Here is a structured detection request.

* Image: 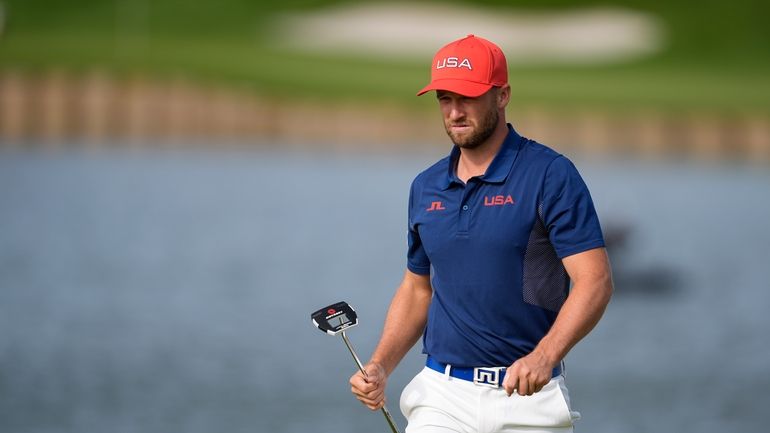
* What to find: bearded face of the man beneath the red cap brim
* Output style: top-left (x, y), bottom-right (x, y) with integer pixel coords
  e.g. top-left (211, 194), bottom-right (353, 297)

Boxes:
top-left (436, 87), bottom-right (500, 149)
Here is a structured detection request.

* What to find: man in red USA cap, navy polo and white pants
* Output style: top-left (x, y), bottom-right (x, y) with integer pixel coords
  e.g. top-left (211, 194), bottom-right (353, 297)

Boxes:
top-left (350, 35), bottom-right (612, 433)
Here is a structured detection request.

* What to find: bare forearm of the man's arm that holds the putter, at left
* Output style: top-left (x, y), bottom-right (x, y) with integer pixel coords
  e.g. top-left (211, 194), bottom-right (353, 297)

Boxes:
top-left (371, 272), bottom-right (432, 374)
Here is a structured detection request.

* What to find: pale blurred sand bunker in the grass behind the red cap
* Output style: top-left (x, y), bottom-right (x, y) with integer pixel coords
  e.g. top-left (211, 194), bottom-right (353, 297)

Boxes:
top-left (275, 3), bottom-right (663, 63)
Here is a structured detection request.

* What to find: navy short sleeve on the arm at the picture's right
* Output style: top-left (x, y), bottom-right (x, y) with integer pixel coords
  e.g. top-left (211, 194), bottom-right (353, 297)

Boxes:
top-left (539, 156), bottom-right (604, 259)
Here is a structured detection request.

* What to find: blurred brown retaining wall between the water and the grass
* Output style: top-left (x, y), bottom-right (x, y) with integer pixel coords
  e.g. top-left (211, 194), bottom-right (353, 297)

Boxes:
top-left (0, 72), bottom-right (770, 163)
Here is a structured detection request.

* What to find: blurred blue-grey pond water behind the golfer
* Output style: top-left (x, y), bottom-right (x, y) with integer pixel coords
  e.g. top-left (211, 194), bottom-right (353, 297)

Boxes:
top-left (0, 150), bottom-right (770, 433)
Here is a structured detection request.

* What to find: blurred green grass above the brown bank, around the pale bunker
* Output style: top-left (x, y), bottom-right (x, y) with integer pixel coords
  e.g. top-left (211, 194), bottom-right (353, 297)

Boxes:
top-left (0, 0), bottom-right (770, 114)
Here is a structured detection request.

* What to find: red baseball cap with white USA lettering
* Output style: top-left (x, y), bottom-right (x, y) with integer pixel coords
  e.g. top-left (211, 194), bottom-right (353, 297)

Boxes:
top-left (417, 35), bottom-right (508, 98)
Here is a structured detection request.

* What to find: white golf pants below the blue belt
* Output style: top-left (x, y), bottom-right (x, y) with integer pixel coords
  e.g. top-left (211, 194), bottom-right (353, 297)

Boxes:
top-left (400, 367), bottom-right (580, 433)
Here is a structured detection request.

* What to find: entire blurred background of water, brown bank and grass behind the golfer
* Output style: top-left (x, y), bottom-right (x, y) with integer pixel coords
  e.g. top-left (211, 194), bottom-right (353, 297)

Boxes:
top-left (0, 0), bottom-right (770, 433)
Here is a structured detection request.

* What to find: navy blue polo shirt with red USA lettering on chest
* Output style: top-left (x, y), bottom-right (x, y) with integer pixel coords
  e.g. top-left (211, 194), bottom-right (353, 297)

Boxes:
top-left (407, 125), bottom-right (604, 367)
